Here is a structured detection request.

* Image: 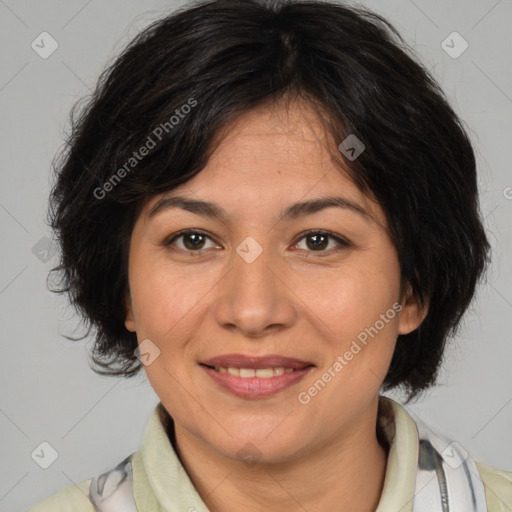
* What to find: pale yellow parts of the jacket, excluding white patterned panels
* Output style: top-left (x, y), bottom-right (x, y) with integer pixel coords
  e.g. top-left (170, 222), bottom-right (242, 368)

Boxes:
top-left (27, 398), bottom-right (512, 512)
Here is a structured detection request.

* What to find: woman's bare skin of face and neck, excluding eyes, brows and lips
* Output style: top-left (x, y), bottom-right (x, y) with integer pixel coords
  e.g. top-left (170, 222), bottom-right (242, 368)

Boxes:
top-left (125, 97), bottom-right (427, 512)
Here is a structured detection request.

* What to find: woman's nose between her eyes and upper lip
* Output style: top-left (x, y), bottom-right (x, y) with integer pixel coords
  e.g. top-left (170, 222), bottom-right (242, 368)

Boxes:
top-left (214, 241), bottom-right (297, 338)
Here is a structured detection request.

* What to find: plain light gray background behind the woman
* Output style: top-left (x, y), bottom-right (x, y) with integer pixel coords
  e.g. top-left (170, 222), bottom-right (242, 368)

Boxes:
top-left (0, 0), bottom-right (512, 511)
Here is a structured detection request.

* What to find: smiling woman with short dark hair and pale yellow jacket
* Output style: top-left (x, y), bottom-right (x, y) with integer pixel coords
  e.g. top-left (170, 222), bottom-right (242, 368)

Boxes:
top-left (31, 0), bottom-right (512, 512)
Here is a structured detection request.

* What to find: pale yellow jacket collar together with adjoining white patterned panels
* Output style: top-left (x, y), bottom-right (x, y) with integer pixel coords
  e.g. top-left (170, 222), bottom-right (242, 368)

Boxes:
top-left (90, 397), bottom-right (487, 512)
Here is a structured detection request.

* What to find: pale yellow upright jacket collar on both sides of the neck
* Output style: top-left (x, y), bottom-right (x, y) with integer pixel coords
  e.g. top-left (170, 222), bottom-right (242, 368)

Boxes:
top-left (132, 397), bottom-right (419, 512)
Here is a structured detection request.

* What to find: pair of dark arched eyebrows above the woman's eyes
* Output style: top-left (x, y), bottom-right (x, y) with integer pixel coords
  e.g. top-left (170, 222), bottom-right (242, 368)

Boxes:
top-left (147, 196), bottom-right (376, 222)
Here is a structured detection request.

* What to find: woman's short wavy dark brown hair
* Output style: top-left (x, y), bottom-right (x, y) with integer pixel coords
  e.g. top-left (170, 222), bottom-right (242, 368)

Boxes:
top-left (48, 0), bottom-right (490, 398)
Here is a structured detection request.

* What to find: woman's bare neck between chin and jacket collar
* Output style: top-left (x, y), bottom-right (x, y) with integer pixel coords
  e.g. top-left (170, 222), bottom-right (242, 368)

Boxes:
top-left (161, 397), bottom-right (388, 512)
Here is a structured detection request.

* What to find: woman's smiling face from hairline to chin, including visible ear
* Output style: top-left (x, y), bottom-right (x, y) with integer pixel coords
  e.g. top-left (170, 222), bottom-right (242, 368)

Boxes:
top-left (126, 99), bottom-right (424, 462)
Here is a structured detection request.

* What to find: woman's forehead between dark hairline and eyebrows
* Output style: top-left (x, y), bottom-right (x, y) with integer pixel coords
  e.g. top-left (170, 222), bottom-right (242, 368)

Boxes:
top-left (145, 97), bottom-right (386, 225)
